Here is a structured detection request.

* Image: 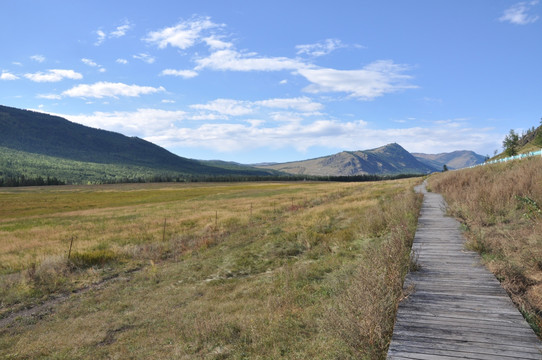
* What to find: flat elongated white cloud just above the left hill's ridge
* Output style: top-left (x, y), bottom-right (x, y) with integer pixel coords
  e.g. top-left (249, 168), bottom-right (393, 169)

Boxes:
top-left (62, 82), bottom-right (165, 99)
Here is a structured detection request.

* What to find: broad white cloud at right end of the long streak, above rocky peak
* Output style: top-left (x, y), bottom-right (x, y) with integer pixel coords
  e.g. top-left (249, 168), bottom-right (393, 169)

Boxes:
top-left (298, 61), bottom-right (417, 100)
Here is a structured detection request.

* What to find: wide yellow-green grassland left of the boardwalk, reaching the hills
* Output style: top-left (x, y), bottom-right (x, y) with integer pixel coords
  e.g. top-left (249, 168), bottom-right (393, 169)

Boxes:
top-left (0, 179), bottom-right (421, 359)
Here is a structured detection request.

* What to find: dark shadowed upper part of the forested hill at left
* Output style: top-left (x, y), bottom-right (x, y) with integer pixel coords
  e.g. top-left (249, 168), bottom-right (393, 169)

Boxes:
top-left (0, 106), bottom-right (268, 179)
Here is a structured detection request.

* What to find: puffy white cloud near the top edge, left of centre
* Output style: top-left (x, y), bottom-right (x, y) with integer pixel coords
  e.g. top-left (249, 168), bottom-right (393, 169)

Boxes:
top-left (143, 17), bottom-right (222, 50)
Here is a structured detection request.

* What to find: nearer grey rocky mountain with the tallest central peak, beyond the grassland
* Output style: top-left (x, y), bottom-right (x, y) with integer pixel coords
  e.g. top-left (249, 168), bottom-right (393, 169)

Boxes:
top-left (258, 144), bottom-right (437, 176)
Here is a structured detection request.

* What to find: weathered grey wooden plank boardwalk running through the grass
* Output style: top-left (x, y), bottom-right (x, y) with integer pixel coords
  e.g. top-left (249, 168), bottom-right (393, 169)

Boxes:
top-left (387, 186), bottom-right (542, 359)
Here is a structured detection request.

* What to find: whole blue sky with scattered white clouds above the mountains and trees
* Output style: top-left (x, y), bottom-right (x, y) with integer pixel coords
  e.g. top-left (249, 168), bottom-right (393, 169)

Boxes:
top-left (0, 0), bottom-right (542, 163)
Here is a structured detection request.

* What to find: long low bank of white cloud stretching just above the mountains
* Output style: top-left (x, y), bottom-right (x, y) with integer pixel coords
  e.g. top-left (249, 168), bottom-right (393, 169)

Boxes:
top-left (44, 105), bottom-right (500, 162)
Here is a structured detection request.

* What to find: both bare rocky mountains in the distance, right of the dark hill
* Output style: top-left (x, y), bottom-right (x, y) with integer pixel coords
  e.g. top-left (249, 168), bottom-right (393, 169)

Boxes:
top-left (254, 143), bottom-right (484, 176)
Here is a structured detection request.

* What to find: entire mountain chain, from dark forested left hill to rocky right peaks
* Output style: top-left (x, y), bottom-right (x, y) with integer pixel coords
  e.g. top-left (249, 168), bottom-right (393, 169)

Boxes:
top-left (0, 106), bottom-right (484, 183)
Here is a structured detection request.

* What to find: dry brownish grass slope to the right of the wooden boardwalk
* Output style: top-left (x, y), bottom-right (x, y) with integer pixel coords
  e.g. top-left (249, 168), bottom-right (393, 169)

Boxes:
top-left (429, 158), bottom-right (542, 335)
